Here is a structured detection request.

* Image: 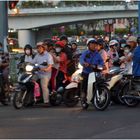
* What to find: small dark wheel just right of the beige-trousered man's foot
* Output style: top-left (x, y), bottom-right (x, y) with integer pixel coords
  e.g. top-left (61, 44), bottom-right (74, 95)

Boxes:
top-left (50, 93), bottom-right (62, 106)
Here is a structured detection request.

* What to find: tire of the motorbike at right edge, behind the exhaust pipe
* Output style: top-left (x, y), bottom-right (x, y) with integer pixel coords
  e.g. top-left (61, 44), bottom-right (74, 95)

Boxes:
top-left (122, 83), bottom-right (139, 107)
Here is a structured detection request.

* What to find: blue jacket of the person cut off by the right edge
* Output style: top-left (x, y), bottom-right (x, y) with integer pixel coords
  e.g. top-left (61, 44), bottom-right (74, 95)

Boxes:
top-left (132, 46), bottom-right (140, 76)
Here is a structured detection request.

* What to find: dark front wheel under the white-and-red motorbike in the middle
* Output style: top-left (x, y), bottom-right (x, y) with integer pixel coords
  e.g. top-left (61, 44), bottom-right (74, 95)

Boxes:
top-left (63, 88), bottom-right (79, 107)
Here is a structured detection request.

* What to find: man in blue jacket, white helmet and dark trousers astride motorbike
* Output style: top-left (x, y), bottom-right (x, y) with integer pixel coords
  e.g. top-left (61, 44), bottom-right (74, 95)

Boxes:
top-left (80, 38), bottom-right (104, 104)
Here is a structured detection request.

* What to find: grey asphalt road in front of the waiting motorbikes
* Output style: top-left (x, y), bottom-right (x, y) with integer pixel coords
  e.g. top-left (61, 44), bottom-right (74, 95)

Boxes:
top-left (0, 105), bottom-right (140, 139)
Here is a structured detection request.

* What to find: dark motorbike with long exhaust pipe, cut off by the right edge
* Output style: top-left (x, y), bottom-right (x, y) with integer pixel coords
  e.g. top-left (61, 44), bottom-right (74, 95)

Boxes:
top-left (122, 74), bottom-right (140, 107)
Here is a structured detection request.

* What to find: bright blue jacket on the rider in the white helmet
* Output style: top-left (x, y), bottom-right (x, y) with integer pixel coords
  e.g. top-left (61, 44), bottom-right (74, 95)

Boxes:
top-left (80, 50), bottom-right (104, 74)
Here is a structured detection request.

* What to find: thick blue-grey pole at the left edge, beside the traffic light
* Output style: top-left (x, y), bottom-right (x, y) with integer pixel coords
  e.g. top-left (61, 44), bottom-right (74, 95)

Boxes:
top-left (0, 1), bottom-right (8, 52)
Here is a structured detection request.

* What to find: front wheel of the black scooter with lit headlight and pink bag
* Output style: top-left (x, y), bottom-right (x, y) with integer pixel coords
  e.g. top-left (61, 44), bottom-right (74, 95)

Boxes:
top-left (13, 90), bottom-right (27, 109)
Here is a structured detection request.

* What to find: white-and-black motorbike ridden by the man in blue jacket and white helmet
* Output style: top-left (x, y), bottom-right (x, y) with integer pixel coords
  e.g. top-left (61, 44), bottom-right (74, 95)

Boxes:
top-left (84, 66), bottom-right (110, 111)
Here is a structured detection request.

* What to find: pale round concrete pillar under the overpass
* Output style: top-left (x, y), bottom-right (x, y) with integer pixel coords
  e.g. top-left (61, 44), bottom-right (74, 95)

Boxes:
top-left (18, 30), bottom-right (36, 48)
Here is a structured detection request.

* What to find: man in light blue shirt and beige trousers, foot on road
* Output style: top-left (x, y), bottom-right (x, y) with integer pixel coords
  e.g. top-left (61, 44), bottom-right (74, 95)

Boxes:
top-left (33, 42), bottom-right (53, 107)
